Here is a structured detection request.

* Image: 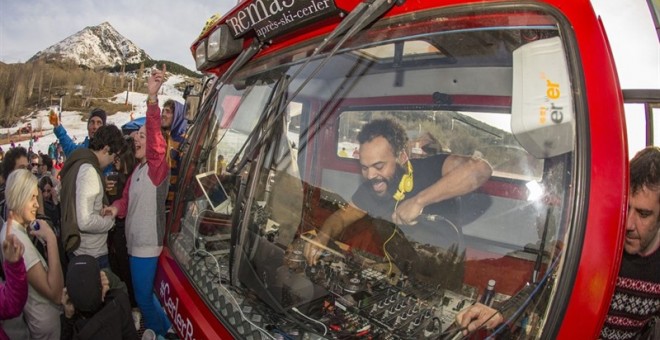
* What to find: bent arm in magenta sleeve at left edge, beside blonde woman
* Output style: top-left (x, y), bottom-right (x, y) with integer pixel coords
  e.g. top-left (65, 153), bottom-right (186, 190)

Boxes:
top-left (0, 234), bottom-right (27, 339)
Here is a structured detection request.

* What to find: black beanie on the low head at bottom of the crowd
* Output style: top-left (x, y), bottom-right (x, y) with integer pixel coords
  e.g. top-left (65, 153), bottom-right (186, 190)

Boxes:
top-left (66, 255), bottom-right (103, 313)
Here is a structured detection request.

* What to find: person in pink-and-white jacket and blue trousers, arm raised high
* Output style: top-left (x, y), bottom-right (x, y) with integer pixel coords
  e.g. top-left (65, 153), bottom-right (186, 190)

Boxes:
top-left (102, 65), bottom-right (171, 337)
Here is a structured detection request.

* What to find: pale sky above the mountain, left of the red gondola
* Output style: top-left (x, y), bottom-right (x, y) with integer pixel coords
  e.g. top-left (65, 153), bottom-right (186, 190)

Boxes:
top-left (0, 0), bottom-right (236, 70)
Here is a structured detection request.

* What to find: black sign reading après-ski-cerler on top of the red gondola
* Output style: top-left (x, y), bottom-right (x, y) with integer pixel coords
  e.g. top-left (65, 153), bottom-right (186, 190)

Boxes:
top-left (226, 0), bottom-right (337, 40)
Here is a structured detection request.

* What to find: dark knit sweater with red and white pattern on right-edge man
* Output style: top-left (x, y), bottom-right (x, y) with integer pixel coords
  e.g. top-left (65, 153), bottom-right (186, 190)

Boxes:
top-left (600, 250), bottom-right (660, 340)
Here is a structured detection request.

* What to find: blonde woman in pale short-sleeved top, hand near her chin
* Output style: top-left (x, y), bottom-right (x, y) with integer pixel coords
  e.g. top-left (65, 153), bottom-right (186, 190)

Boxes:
top-left (0, 169), bottom-right (64, 339)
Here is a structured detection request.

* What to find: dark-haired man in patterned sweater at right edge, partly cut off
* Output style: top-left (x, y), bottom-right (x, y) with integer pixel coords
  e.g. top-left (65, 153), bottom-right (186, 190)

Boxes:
top-left (600, 146), bottom-right (660, 340)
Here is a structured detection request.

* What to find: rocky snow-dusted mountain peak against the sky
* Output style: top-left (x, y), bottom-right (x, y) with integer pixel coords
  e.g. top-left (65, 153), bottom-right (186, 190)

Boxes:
top-left (30, 21), bottom-right (151, 69)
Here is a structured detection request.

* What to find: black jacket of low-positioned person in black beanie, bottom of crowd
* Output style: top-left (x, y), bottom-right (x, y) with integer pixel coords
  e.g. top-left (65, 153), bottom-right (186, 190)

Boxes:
top-left (60, 289), bottom-right (138, 340)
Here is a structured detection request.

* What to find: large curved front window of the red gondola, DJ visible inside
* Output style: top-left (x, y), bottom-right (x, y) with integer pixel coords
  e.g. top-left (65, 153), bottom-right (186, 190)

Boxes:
top-left (170, 5), bottom-right (579, 339)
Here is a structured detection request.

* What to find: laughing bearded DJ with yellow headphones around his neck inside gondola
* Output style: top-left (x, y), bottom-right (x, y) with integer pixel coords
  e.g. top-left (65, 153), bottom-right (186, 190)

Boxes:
top-left (304, 119), bottom-right (492, 264)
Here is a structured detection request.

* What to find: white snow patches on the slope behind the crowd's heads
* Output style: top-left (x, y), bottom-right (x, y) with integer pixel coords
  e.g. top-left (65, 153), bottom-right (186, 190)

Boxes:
top-left (0, 75), bottom-right (183, 153)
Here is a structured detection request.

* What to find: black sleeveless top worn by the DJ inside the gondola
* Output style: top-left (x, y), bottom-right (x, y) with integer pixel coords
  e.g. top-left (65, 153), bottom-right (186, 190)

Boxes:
top-left (352, 154), bottom-right (462, 249)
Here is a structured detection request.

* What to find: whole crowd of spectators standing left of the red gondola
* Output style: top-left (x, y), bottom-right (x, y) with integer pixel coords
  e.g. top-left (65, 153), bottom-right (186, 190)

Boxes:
top-left (0, 68), bottom-right (187, 340)
